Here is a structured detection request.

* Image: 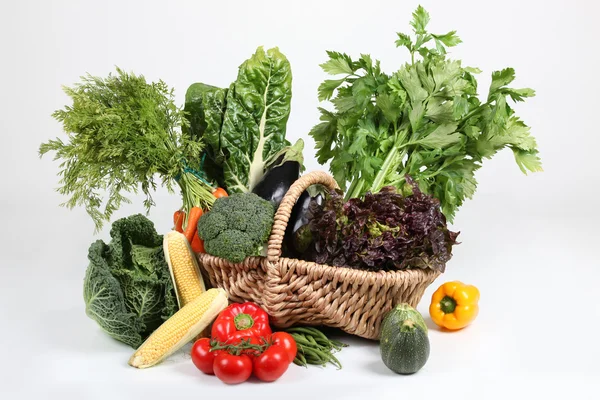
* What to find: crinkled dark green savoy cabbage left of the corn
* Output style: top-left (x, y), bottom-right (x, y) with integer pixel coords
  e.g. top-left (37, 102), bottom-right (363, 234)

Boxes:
top-left (83, 214), bottom-right (177, 348)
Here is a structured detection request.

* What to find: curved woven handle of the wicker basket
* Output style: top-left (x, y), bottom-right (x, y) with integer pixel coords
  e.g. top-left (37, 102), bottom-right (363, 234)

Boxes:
top-left (267, 171), bottom-right (338, 265)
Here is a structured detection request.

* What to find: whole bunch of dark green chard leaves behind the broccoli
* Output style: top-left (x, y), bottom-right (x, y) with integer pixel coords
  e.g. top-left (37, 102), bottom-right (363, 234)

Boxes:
top-left (186, 47), bottom-right (302, 193)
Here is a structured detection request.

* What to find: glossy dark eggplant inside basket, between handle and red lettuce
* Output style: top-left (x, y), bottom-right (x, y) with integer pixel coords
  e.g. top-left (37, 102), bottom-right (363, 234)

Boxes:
top-left (283, 190), bottom-right (323, 258)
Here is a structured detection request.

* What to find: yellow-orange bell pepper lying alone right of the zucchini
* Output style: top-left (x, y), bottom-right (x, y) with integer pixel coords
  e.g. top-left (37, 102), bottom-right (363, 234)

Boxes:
top-left (429, 281), bottom-right (479, 330)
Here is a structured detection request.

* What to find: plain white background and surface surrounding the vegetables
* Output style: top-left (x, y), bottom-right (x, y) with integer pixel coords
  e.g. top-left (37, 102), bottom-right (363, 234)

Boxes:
top-left (0, 0), bottom-right (600, 399)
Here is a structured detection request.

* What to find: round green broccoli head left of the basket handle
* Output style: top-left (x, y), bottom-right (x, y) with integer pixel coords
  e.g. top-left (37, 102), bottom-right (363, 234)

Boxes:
top-left (198, 193), bottom-right (275, 262)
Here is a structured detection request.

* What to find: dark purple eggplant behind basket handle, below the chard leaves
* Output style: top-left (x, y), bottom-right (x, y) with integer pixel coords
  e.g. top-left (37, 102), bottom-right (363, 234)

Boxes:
top-left (252, 161), bottom-right (300, 209)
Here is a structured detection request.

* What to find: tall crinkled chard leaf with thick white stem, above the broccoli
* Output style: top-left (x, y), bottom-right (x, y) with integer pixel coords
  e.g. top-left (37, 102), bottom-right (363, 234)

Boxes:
top-left (221, 47), bottom-right (292, 193)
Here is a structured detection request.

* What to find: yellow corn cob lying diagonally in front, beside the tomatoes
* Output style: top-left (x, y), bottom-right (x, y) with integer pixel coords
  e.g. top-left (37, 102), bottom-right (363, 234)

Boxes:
top-left (129, 289), bottom-right (227, 368)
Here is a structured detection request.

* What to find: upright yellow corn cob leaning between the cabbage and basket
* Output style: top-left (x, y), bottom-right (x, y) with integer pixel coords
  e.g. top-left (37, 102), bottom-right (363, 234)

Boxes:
top-left (163, 231), bottom-right (206, 307)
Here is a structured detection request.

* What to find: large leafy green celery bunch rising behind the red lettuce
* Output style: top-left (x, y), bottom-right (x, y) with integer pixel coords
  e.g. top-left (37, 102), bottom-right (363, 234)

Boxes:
top-left (310, 6), bottom-right (542, 220)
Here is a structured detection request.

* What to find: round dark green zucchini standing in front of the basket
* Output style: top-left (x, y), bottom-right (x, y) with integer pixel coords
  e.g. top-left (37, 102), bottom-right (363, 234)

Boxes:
top-left (379, 304), bottom-right (430, 374)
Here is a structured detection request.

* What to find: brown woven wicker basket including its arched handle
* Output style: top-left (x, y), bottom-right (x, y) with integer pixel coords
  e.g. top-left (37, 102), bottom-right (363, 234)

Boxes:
top-left (199, 171), bottom-right (439, 339)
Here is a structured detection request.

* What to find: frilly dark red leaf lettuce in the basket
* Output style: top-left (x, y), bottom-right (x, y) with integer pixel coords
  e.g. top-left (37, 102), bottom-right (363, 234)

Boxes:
top-left (307, 177), bottom-right (458, 272)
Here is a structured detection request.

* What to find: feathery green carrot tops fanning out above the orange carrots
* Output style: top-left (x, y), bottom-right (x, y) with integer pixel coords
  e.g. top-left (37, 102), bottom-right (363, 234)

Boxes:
top-left (39, 68), bottom-right (214, 230)
